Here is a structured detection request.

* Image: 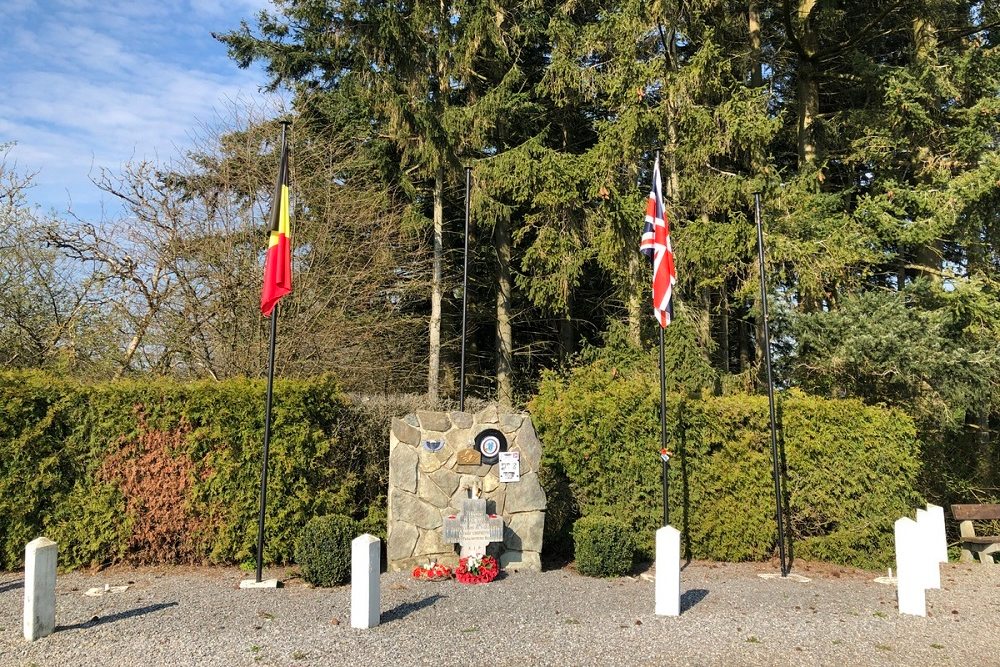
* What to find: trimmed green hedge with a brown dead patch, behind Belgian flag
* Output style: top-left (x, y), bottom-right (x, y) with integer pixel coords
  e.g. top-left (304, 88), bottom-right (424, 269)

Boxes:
top-left (0, 373), bottom-right (388, 569)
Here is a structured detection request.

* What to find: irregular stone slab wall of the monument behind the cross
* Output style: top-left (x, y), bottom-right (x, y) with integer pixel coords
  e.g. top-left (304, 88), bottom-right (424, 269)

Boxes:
top-left (387, 406), bottom-right (545, 570)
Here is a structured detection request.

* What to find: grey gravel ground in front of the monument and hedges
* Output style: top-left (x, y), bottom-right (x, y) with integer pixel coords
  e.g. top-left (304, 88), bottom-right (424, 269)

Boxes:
top-left (0, 562), bottom-right (1000, 667)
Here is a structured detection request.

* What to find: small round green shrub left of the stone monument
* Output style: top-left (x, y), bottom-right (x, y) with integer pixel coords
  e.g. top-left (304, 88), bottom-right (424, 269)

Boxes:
top-left (295, 514), bottom-right (361, 586)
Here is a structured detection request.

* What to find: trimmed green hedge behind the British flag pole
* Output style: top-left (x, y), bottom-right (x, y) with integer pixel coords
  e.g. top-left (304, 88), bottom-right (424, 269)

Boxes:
top-left (531, 359), bottom-right (920, 568)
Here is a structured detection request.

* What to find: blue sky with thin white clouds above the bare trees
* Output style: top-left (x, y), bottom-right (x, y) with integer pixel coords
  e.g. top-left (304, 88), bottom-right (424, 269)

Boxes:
top-left (0, 0), bottom-right (278, 218)
